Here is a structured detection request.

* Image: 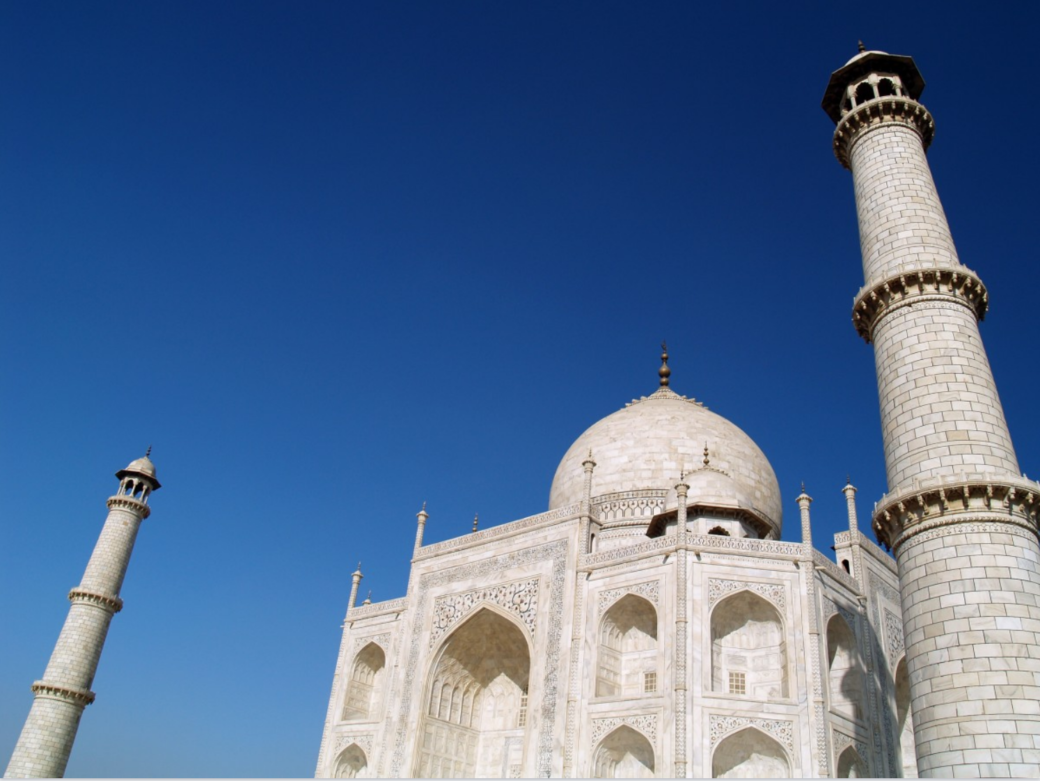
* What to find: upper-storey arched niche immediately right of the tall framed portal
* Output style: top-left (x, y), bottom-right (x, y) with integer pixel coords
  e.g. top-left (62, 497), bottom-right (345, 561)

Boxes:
top-left (596, 594), bottom-right (657, 697)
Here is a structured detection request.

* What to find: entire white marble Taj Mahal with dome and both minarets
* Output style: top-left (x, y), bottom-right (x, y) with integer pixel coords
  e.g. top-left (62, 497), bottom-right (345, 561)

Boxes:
top-left (6, 47), bottom-right (1040, 778)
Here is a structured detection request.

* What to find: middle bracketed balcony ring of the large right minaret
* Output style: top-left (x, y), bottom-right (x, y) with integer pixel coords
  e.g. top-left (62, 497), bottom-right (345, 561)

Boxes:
top-left (852, 266), bottom-right (989, 344)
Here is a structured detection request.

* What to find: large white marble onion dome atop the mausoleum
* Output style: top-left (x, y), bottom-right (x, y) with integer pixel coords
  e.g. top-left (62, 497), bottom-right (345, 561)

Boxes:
top-left (549, 388), bottom-right (783, 538)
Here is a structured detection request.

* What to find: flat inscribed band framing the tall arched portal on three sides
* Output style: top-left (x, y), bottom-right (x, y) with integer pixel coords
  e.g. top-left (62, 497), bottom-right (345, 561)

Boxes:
top-left (389, 540), bottom-right (568, 778)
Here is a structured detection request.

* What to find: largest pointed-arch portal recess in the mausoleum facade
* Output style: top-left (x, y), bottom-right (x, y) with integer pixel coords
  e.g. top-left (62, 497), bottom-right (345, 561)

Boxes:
top-left (415, 607), bottom-right (530, 778)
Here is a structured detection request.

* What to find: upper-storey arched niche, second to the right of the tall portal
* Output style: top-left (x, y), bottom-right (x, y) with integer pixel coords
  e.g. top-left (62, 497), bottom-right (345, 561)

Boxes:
top-left (711, 591), bottom-right (788, 700)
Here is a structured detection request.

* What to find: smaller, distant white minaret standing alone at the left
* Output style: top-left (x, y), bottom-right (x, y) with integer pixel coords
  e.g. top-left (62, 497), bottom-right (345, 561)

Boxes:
top-left (4, 448), bottom-right (159, 778)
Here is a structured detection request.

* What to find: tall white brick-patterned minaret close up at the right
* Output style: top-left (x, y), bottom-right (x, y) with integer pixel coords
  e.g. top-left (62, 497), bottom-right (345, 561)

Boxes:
top-left (823, 45), bottom-right (1040, 777)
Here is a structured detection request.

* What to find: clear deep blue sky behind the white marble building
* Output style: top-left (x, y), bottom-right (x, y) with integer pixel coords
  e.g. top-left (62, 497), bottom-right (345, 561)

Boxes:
top-left (0, 2), bottom-right (1040, 776)
